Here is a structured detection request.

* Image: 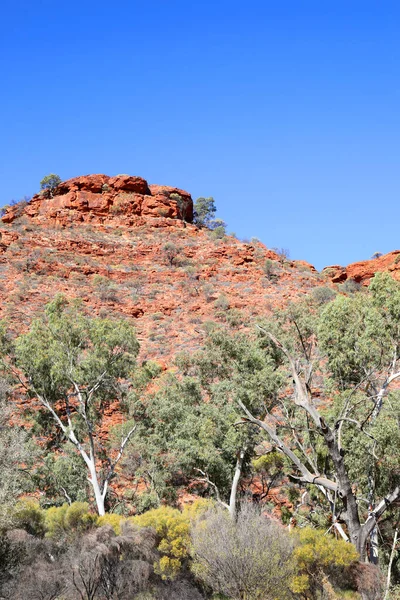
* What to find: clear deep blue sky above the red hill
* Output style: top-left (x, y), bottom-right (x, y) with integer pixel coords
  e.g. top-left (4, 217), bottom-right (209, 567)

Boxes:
top-left (0, 0), bottom-right (400, 268)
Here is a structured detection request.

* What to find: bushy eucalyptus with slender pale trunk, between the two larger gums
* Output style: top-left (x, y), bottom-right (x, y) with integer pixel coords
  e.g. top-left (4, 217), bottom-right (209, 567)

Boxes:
top-left (128, 326), bottom-right (280, 517)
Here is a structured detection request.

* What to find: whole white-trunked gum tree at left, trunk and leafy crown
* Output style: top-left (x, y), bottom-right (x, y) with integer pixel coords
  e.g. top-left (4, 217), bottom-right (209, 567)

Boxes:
top-left (10, 296), bottom-right (139, 515)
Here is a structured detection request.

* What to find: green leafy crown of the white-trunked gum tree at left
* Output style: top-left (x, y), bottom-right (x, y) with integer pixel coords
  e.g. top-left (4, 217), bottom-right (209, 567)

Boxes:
top-left (16, 296), bottom-right (139, 403)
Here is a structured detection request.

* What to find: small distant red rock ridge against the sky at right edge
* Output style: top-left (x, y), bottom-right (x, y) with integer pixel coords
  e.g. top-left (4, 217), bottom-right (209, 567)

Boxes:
top-left (322, 250), bottom-right (400, 285)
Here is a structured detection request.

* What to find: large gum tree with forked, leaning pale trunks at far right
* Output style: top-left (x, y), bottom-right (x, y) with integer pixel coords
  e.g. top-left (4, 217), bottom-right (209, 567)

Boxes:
top-left (239, 274), bottom-right (400, 562)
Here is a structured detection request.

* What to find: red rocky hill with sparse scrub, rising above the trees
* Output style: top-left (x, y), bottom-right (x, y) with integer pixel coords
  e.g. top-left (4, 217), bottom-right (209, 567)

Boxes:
top-left (0, 175), bottom-right (400, 365)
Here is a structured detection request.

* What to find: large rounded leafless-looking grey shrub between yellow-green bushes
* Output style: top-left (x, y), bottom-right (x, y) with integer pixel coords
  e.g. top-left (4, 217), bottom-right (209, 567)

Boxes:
top-left (192, 505), bottom-right (294, 600)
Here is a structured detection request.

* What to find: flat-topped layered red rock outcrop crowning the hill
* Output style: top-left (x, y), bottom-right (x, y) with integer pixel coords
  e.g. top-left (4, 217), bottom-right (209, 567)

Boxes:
top-left (2, 175), bottom-right (193, 226)
